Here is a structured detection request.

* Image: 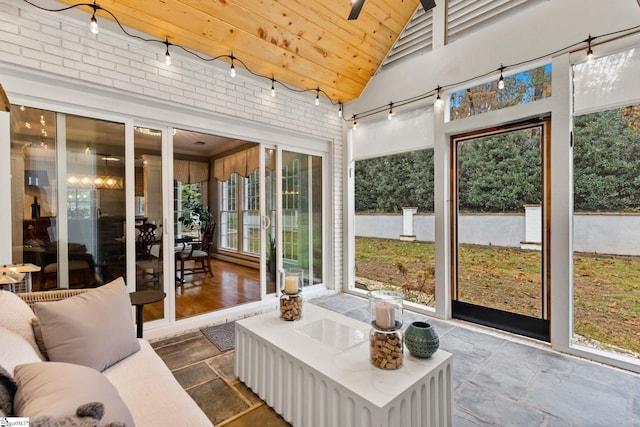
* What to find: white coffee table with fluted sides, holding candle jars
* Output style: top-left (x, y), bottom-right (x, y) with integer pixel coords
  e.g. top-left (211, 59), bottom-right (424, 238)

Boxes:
top-left (235, 303), bottom-right (452, 427)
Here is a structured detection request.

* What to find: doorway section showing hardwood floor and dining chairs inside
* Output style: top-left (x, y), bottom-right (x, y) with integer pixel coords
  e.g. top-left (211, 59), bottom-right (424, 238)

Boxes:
top-left (172, 129), bottom-right (263, 319)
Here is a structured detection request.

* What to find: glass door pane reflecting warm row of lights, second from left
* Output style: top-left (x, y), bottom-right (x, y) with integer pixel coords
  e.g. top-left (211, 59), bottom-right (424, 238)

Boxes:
top-left (65, 115), bottom-right (127, 287)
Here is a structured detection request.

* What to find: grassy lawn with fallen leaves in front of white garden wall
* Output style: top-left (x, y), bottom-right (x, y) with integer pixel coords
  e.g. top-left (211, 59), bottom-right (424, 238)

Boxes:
top-left (356, 237), bottom-right (640, 353)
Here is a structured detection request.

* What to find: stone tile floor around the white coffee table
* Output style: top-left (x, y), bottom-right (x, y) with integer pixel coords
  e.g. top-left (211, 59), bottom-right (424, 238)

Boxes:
top-left (153, 294), bottom-right (640, 427)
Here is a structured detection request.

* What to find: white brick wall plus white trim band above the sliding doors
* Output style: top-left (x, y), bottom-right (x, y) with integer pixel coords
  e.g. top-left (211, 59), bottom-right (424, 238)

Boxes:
top-left (0, 0), bottom-right (343, 300)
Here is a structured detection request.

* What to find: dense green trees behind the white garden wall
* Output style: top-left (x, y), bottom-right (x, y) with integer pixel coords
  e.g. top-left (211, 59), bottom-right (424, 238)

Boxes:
top-left (355, 102), bottom-right (640, 213)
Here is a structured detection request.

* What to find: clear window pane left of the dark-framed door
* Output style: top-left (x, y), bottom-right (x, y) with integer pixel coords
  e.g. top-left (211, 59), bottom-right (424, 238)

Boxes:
top-left (355, 150), bottom-right (435, 306)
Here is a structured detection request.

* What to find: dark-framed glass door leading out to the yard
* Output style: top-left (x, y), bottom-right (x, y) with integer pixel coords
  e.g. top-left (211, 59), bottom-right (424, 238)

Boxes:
top-left (451, 119), bottom-right (548, 339)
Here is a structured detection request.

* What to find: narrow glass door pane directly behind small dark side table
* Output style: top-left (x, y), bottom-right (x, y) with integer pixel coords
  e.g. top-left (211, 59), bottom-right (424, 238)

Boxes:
top-left (134, 126), bottom-right (165, 321)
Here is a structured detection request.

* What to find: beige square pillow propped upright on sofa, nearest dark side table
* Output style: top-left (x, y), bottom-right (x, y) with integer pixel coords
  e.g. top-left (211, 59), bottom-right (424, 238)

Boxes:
top-left (34, 278), bottom-right (140, 371)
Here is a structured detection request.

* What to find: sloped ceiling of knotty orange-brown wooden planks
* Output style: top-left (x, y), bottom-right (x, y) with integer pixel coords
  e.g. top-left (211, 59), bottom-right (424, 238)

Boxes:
top-left (60, 0), bottom-right (420, 102)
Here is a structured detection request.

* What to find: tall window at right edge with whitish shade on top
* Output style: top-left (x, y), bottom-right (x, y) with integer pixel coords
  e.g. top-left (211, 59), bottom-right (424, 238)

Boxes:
top-left (572, 48), bottom-right (640, 358)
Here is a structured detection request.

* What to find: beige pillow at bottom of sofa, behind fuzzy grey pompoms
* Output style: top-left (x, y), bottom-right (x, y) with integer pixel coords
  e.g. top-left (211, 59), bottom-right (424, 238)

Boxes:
top-left (13, 362), bottom-right (134, 426)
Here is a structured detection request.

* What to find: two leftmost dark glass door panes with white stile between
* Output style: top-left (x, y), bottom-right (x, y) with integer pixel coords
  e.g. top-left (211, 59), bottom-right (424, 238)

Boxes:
top-left (11, 106), bottom-right (126, 290)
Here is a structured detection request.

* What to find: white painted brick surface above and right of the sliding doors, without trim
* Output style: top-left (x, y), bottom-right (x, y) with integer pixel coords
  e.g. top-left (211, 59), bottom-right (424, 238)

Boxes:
top-left (0, 0), bottom-right (343, 286)
